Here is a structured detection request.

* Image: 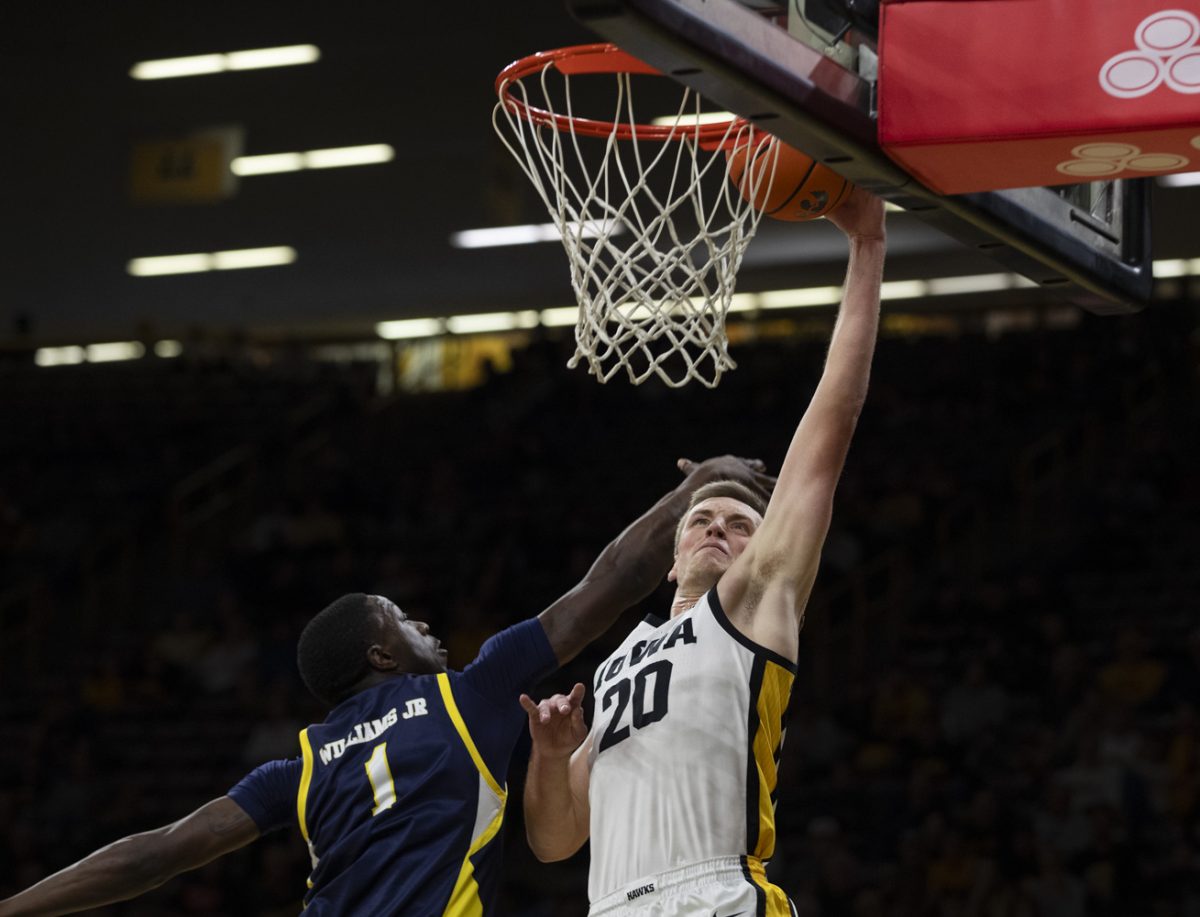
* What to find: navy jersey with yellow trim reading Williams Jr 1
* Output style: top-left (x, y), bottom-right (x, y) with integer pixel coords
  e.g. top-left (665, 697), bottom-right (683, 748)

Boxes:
top-left (229, 619), bottom-right (558, 917)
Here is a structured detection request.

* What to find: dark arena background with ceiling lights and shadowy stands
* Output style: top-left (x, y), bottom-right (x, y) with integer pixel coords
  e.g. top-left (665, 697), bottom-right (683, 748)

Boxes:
top-left (0, 0), bottom-right (1200, 917)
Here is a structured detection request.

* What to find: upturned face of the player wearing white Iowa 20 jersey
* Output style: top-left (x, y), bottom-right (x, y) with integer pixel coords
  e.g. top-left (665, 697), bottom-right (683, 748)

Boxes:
top-left (667, 497), bottom-right (762, 591)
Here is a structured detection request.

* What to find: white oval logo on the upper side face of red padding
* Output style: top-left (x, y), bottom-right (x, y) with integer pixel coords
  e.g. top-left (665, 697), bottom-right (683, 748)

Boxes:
top-left (1100, 10), bottom-right (1200, 98)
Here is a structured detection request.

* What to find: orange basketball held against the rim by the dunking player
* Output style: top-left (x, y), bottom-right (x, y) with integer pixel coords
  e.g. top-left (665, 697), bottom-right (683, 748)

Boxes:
top-left (726, 138), bottom-right (853, 222)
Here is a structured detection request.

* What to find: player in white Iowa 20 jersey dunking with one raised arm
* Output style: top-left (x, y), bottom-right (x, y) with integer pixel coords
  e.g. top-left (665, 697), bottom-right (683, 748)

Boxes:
top-left (522, 190), bottom-right (886, 917)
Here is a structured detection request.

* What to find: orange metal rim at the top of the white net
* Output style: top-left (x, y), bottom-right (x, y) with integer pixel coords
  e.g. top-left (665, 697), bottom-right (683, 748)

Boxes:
top-left (496, 43), bottom-right (740, 146)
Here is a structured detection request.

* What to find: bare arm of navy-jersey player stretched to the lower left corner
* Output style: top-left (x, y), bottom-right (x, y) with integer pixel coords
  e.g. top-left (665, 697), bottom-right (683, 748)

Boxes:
top-left (0, 796), bottom-right (258, 917)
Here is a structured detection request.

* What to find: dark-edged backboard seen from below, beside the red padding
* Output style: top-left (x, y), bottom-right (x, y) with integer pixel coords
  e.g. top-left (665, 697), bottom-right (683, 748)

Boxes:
top-left (566, 0), bottom-right (1153, 313)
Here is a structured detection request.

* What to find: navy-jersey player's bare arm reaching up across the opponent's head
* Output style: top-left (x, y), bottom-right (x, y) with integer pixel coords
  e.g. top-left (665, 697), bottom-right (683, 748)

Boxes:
top-left (538, 455), bottom-right (774, 665)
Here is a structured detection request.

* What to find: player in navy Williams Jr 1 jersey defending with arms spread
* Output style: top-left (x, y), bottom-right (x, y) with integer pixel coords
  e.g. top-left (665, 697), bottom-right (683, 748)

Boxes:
top-left (0, 456), bottom-right (772, 917)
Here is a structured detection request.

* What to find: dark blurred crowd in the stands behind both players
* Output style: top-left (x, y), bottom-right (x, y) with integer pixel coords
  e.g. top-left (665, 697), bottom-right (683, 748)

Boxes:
top-left (0, 306), bottom-right (1200, 917)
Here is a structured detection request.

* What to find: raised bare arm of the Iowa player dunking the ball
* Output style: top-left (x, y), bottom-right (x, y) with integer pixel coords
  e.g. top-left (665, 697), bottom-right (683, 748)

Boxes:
top-left (718, 190), bottom-right (886, 659)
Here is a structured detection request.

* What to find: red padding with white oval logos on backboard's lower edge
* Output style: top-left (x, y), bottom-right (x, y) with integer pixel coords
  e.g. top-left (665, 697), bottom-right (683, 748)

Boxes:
top-left (878, 0), bottom-right (1200, 193)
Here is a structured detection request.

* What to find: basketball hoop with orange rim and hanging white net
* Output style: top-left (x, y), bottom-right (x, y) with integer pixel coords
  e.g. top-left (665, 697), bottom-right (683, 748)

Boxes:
top-left (492, 44), bottom-right (775, 388)
